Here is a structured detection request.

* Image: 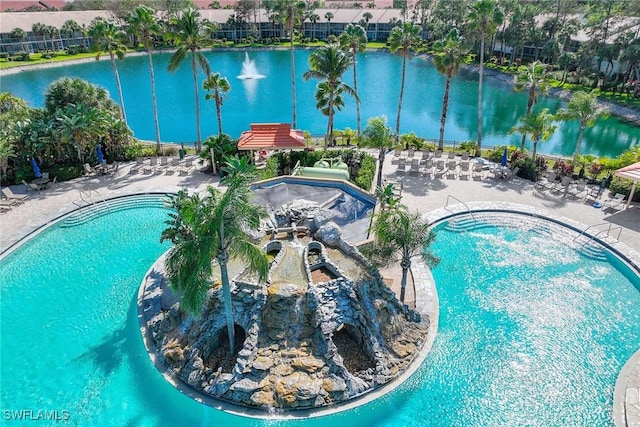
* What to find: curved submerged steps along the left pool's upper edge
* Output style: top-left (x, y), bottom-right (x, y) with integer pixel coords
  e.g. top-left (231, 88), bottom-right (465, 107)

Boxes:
top-left (60, 194), bottom-right (166, 228)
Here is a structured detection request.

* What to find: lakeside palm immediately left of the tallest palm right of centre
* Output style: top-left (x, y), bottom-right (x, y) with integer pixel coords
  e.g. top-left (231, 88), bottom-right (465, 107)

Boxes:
top-left (433, 28), bottom-right (469, 150)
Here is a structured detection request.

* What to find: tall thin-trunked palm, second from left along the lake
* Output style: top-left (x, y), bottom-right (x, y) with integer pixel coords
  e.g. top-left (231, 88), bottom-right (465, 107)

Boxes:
top-left (127, 6), bottom-right (162, 155)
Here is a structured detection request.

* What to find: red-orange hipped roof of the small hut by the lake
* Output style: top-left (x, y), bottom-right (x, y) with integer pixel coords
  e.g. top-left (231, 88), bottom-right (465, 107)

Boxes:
top-left (238, 123), bottom-right (306, 150)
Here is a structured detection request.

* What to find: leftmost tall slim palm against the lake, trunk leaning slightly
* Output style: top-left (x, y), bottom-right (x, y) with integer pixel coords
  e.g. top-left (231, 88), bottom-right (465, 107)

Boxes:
top-left (89, 18), bottom-right (127, 127)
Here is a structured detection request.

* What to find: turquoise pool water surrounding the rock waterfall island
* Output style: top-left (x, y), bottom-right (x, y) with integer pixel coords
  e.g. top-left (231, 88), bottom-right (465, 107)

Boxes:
top-left (0, 207), bottom-right (640, 427)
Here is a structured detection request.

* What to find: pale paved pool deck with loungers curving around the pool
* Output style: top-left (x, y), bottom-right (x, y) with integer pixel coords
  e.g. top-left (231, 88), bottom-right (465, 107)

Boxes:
top-left (0, 155), bottom-right (640, 426)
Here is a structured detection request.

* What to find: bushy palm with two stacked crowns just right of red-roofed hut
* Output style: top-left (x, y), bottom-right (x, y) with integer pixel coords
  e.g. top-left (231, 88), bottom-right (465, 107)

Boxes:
top-left (302, 43), bottom-right (358, 150)
